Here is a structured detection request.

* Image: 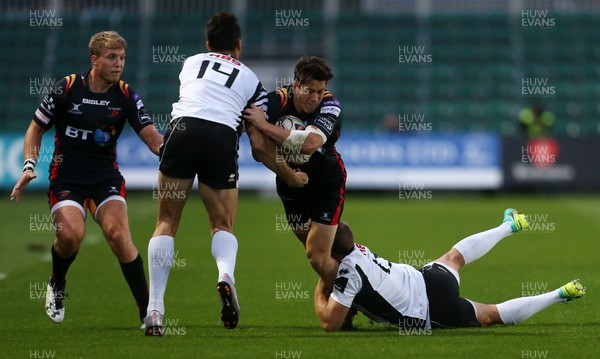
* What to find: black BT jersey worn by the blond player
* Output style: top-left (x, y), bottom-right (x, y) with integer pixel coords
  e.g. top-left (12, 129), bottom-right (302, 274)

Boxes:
top-left (33, 71), bottom-right (153, 184)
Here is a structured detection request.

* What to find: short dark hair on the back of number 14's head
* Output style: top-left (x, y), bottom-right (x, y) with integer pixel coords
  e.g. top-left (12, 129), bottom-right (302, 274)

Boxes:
top-left (206, 12), bottom-right (242, 51)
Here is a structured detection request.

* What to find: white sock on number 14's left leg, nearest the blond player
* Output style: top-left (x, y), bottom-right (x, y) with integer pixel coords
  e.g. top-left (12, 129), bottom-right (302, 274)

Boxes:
top-left (148, 236), bottom-right (175, 315)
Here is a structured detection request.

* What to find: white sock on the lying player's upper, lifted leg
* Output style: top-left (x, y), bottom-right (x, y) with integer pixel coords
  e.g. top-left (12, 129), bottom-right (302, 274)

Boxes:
top-left (453, 222), bottom-right (512, 264)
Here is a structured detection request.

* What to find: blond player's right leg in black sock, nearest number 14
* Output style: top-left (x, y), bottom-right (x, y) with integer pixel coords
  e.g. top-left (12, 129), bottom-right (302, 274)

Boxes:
top-left (94, 196), bottom-right (148, 324)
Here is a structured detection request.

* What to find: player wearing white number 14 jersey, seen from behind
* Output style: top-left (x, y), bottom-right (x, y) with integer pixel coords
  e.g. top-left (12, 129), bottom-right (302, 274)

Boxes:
top-left (145, 13), bottom-right (304, 336)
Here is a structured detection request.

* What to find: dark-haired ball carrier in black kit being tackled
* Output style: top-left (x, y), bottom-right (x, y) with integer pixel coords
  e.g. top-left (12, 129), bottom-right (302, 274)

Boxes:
top-left (243, 56), bottom-right (346, 290)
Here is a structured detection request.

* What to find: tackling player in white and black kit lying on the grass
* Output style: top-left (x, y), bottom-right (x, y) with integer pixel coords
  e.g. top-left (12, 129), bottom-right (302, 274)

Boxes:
top-left (315, 208), bottom-right (586, 331)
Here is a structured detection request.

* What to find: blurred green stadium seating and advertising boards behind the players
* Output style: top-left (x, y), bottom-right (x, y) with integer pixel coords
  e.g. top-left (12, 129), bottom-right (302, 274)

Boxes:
top-left (0, 0), bottom-right (600, 194)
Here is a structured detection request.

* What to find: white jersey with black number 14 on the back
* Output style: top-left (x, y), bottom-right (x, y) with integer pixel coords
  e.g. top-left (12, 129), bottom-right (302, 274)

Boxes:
top-left (171, 52), bottom-right (267, 130)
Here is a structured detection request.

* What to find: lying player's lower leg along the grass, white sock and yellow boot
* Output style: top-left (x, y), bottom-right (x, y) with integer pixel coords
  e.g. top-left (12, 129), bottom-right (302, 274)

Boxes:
top-left (471, 279), bottom-right (586, 327)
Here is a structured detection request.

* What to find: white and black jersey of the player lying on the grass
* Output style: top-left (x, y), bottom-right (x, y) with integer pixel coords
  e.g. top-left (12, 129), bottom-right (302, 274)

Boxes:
top-left (331, 244), bottom-right (430, 328)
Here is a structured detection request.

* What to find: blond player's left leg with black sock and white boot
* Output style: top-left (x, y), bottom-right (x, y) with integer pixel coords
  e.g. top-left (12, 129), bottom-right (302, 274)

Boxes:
top-left (44, 201), bottom-right (85, 324)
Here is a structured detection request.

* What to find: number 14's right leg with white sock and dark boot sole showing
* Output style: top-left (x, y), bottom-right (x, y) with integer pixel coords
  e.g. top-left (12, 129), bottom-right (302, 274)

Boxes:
top-left (198, 183), bottom-right (240, 329)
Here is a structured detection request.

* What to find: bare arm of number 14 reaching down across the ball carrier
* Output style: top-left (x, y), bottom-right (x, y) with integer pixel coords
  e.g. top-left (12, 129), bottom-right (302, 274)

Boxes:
top-left (246, 125), bottom-right (308, 188)
